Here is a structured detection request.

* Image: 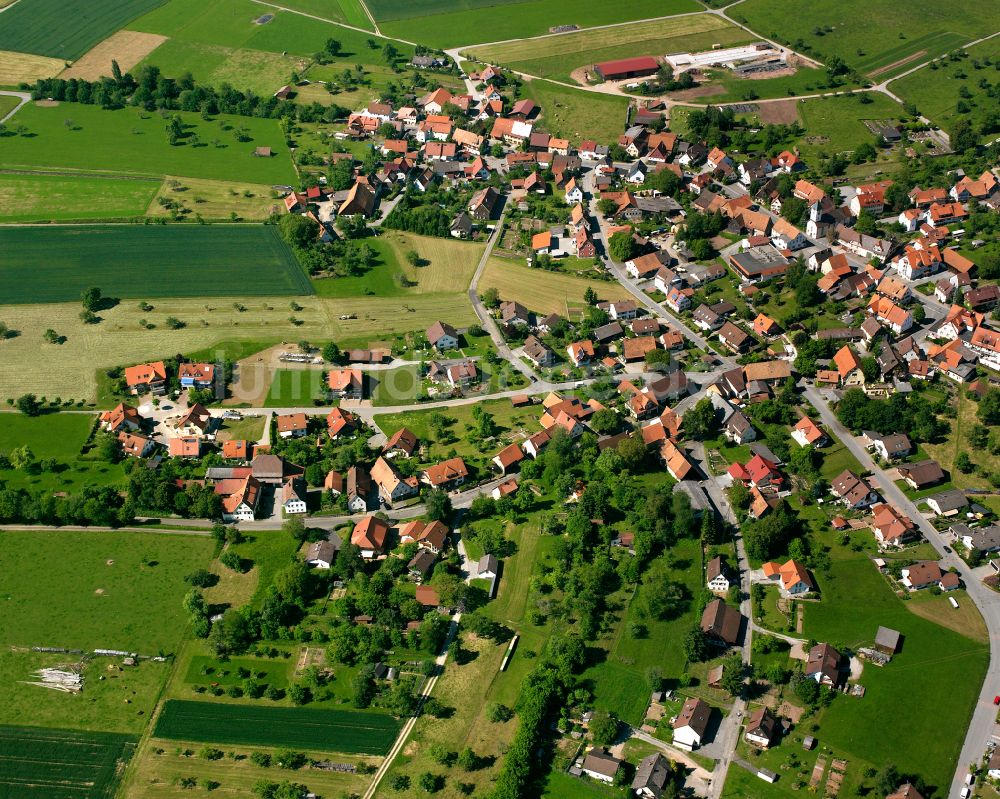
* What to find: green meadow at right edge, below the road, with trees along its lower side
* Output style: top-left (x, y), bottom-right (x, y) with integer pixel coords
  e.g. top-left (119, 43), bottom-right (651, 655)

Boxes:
top-left (891, 37), bottom-right (1000, 139)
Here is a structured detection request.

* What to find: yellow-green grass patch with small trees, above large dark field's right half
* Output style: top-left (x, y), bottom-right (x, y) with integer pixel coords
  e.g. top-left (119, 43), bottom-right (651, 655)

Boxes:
top-left (144, 176), bottom-right (283, 222)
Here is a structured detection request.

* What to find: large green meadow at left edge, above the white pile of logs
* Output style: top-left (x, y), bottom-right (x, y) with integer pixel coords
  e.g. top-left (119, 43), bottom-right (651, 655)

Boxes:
top-left (0, 532), bottom-right (213, 655)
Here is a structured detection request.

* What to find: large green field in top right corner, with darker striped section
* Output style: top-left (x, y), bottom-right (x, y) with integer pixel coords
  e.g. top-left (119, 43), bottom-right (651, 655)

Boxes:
top-left (732, 0), bottom-right (1000, 79)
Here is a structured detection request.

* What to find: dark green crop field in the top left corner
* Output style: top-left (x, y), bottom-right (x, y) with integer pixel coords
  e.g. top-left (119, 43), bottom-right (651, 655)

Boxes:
top-left (0, 0), bottom-right (166, 61)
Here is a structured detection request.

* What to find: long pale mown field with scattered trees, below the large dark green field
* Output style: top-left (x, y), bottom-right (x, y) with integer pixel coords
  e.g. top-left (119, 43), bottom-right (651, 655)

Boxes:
top-left (0, 294), bottom-right (476, 407)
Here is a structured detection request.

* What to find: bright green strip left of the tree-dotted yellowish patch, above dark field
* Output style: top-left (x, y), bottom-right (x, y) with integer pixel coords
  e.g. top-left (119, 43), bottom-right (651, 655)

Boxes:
top-left (0, 172), bottom-right (162, 222)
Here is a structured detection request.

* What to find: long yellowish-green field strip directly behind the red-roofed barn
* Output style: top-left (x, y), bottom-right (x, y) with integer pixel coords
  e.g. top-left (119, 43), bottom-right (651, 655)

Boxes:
top-left (465, 14), bottom-right (751, 80)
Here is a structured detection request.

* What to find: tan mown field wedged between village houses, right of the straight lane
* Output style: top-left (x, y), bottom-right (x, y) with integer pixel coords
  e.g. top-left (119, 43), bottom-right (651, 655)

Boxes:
top-left (479, 257), bottom-right (629, 314)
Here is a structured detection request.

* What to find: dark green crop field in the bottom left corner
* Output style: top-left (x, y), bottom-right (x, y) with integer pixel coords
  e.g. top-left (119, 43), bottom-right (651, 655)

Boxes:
top-left (0, 727), bottom-right (136, 799)
